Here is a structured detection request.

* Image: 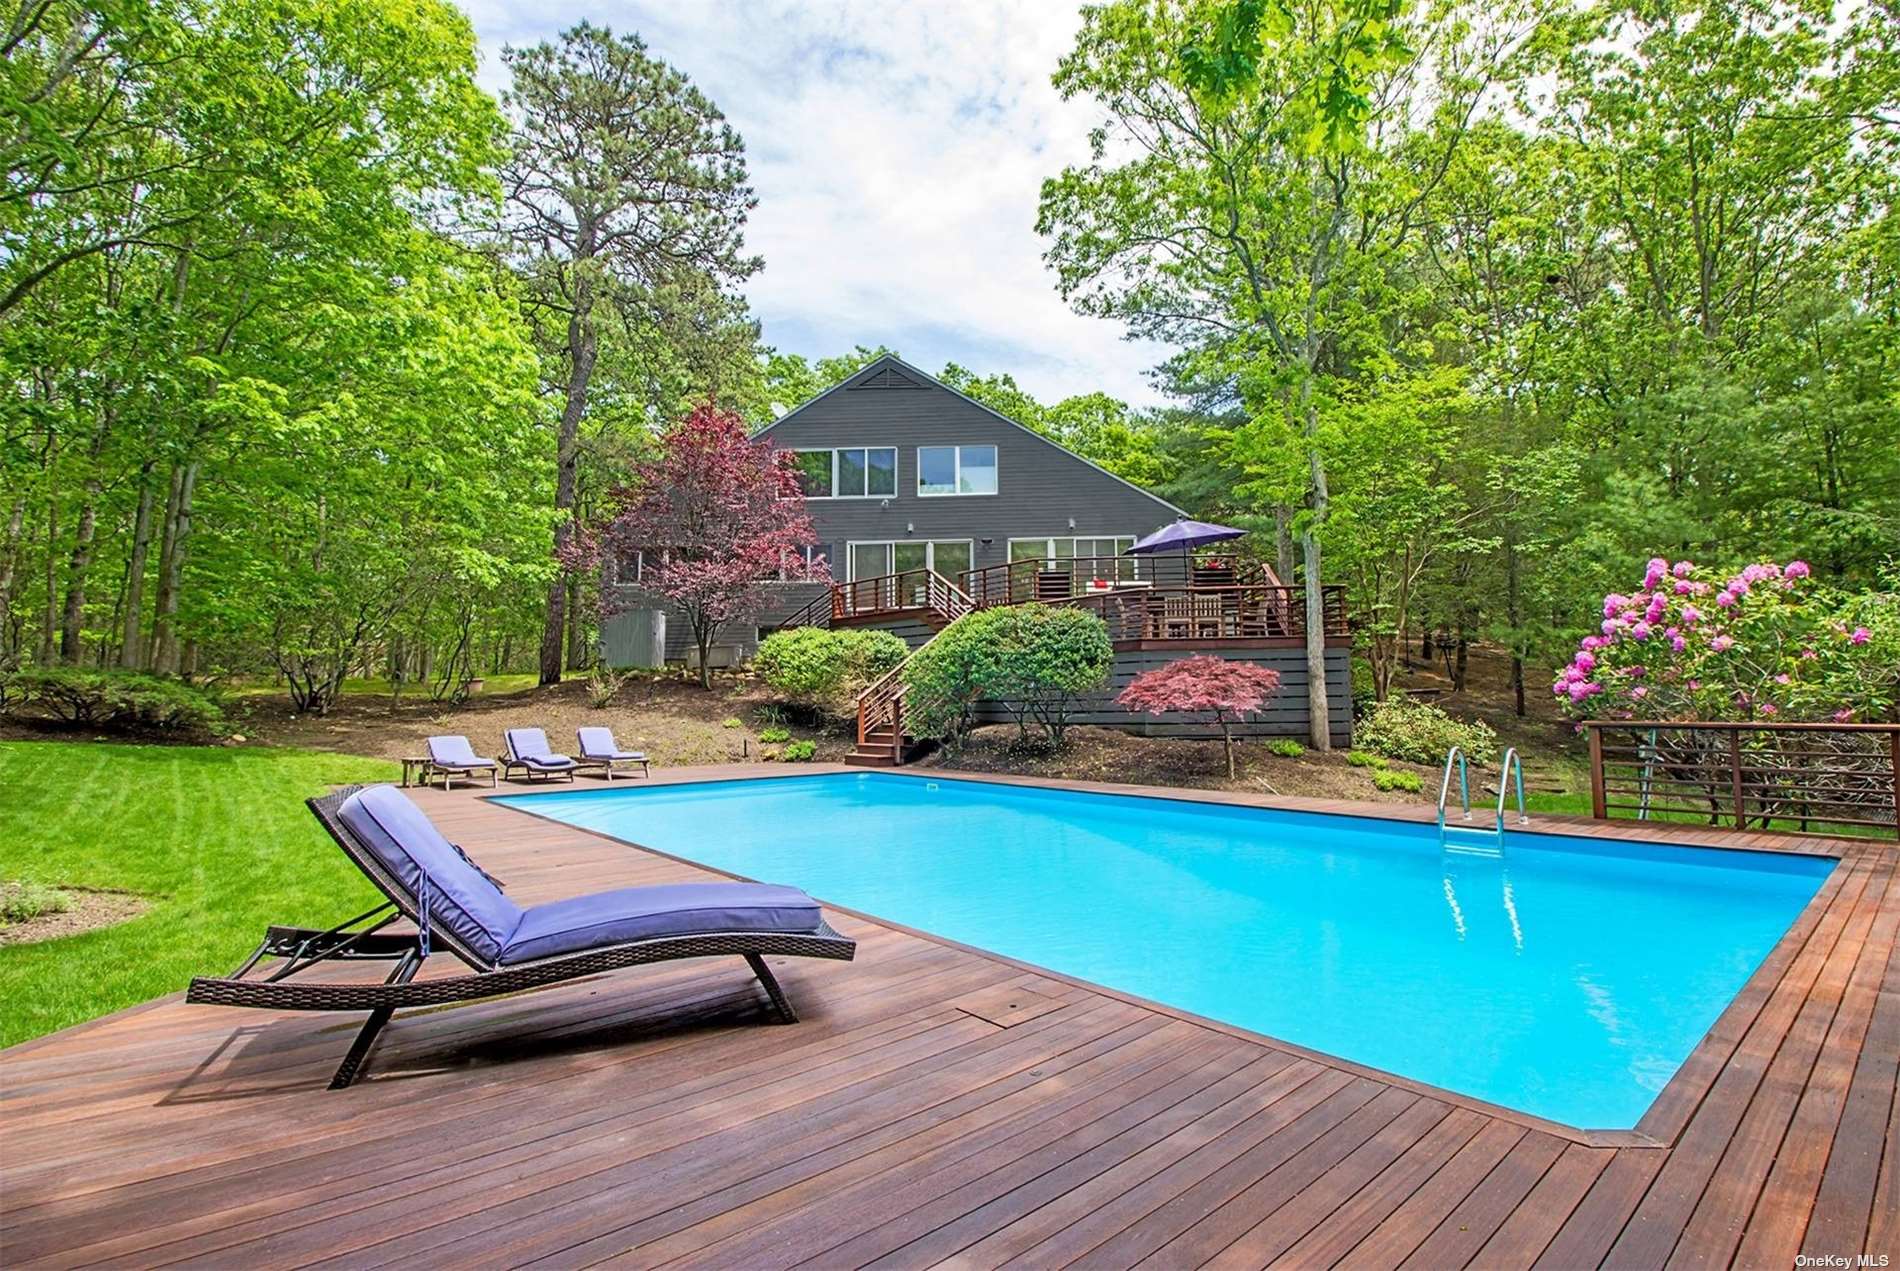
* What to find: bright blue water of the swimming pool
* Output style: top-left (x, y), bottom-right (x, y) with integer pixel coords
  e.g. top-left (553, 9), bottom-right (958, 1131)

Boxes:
top-left (498, 773), bottom-right (1834, 1129)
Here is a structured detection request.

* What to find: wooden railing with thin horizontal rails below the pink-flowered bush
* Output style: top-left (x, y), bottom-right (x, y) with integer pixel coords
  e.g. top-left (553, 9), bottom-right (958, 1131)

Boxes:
top-left (1585, 720), bottom-right (1900, 836)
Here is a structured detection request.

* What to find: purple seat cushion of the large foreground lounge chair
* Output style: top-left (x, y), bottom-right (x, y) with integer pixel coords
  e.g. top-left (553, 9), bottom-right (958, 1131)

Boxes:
top-left (500, 883), bottom-right (819, 965)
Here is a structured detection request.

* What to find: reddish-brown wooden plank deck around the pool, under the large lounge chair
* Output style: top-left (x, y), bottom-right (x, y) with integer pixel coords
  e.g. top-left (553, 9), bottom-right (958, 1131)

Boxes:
top-left (0, 768), bottom-right (1900, 1269)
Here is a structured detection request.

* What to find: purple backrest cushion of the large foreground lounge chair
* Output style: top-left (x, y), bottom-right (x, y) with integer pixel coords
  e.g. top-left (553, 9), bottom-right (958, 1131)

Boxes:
top-left (336, 785), bottom-right (523, 963)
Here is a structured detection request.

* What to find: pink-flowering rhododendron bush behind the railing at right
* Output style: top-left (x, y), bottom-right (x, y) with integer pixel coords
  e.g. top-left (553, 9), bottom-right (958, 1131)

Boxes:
top-left (1550, 557), bottom-right (1900, 724)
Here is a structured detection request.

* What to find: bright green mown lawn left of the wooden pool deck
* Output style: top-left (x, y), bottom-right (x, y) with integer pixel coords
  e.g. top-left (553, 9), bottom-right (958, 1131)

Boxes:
top-left (0, 741), bottom-right (397, 1045)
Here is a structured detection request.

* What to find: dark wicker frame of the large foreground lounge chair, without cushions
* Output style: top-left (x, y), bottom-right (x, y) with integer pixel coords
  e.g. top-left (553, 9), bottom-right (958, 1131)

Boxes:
top-left (184, 787), bottom-right (857, 1091)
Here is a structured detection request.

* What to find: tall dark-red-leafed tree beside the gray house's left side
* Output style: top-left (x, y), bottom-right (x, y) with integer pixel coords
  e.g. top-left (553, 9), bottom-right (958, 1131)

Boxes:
top-left (581, 403), bottom-right (827, 688)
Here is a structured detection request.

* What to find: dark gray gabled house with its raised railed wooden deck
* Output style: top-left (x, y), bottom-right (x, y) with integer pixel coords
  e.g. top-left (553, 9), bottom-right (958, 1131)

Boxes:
top-left (604, 357), bottom-right (1351, 752)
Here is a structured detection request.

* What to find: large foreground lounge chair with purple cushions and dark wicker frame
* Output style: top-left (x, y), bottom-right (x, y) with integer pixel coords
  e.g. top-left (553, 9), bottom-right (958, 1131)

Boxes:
top-left (184, 785), bottom-right (857, 1091)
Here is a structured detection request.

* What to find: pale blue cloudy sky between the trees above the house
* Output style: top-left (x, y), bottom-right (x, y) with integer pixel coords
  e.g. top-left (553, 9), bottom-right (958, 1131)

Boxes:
top-left (462, 0), bottom-right (1165, 405)
